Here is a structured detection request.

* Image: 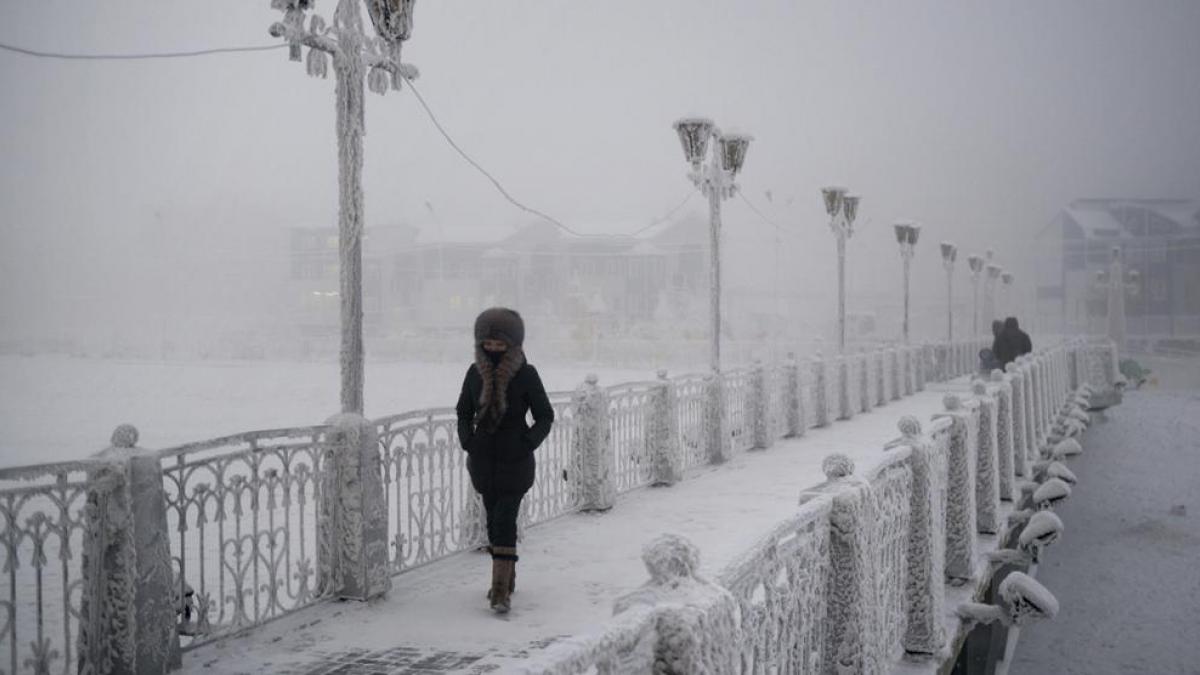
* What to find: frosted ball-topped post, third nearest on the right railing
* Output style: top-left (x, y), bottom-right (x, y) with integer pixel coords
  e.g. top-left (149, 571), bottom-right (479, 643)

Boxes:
top-left (898, 416), bottom-right (947, 655)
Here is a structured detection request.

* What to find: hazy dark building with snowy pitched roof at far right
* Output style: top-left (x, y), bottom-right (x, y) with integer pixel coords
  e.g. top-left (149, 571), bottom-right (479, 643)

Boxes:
top-left (1037, 199), bottom-right (1200, 336)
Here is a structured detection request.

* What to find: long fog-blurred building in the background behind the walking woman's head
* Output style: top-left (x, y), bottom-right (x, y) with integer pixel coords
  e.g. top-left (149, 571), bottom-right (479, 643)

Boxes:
top-left (290, 212), bottom-right (708, 341)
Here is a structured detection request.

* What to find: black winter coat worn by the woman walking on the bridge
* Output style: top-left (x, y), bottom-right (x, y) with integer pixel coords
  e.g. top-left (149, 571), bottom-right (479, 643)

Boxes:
top-left (455, 363), bottom-right (554, 495)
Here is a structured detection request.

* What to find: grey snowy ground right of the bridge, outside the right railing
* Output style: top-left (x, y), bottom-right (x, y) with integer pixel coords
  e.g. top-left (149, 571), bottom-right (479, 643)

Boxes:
top-left (1009, 388), bottom-right (1200, 675)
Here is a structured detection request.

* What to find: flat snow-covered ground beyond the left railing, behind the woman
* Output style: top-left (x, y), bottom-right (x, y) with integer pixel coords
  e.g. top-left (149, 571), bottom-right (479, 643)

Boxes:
top-left (0, 356), bottom-right (654, 466)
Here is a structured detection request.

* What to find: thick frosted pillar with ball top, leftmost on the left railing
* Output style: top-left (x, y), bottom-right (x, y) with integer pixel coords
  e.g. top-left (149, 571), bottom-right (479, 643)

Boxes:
top-left (79, 424), bottom-right (180, 675)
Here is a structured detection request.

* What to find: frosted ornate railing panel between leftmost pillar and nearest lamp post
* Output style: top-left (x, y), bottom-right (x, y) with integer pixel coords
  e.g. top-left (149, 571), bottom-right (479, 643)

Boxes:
top-left (158, 426), bottom-right (336, 649)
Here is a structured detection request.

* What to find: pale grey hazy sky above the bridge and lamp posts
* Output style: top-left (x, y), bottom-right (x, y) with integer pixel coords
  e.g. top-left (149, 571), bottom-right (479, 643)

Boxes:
top-left (0, 0), bottom-right (1200, 341)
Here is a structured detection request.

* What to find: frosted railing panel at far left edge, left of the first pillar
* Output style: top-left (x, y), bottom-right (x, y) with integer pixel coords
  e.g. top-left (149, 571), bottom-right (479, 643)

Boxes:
top-left (0, 460), bottom-right (115, 675)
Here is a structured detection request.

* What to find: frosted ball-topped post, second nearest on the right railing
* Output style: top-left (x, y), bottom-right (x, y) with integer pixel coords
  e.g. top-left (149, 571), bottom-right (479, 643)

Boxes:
top-left (802, 454), bottom-right (883, 675)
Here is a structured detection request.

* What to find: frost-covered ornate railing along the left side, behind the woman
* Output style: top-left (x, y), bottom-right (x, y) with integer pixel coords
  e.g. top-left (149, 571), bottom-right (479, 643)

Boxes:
top-left (7, 333), bottom-right (1115, 673)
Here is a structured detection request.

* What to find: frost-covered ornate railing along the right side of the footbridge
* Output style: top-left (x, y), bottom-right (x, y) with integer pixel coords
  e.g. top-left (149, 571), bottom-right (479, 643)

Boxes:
top-left (526, 340), bottom-right (1115, 674)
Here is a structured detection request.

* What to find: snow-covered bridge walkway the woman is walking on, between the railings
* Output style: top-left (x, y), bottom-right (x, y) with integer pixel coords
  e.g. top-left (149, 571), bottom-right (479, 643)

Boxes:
top-left (184, 382), bottom-right (966, 675)
